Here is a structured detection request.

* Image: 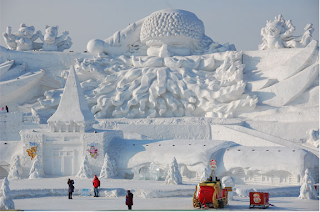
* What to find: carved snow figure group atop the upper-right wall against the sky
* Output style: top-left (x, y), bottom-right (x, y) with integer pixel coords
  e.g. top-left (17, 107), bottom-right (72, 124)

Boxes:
top-left (259, 14), bottom-right (314, 50)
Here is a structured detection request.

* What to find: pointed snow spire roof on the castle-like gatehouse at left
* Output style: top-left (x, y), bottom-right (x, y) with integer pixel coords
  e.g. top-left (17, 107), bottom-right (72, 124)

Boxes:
top-left (48, 66), bottom-right (95, 132)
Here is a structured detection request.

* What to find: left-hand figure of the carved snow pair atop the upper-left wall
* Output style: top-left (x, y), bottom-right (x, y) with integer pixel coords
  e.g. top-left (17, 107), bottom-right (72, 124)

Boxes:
top-left (3, 24), bottom-right (42, 51)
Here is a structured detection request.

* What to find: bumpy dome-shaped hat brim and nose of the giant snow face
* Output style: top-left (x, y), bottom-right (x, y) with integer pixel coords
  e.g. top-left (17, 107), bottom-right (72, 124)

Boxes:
top-left (140, 10), bottom-right (204, 58)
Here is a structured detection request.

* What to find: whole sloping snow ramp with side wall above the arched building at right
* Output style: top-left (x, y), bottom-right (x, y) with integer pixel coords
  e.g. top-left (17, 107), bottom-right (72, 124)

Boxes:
top-left (211, 125), bottom-right (319, 157)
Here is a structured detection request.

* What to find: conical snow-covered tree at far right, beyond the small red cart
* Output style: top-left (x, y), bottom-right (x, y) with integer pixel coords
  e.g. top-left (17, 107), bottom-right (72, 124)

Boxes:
top-left (299, 169), bottom-right (317, 199)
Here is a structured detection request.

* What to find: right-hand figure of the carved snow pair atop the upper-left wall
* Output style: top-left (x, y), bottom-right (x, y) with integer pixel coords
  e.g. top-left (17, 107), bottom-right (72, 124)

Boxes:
top-left (40, 25), bottom-right (72, 52)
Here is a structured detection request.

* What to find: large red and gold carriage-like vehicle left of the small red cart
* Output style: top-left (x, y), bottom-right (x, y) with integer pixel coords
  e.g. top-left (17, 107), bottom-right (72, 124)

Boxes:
top-left (193, 180), bottom-right (228, 208)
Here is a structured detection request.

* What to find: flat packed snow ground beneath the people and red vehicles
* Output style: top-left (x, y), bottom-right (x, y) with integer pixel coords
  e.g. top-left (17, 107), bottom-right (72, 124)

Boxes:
top-left (0, 177), bottom-right (319, 211)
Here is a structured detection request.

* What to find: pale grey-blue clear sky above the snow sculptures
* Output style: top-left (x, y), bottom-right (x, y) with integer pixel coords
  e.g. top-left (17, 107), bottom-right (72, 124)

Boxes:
top-left (0, 0), bottom-right (319, 52)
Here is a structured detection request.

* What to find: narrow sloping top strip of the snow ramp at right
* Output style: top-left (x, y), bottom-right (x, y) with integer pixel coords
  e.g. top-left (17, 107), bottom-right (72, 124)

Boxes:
top-left (224, 125), bottom-right (319, 156)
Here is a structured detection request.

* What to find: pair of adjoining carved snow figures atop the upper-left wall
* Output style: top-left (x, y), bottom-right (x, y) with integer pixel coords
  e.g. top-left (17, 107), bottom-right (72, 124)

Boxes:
top-left (3, 24), bottom-right (72, 51)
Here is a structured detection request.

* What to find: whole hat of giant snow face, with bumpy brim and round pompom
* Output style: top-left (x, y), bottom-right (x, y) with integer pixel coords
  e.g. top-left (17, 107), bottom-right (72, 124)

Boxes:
top-left (87, 9), bottom-right (235, 57)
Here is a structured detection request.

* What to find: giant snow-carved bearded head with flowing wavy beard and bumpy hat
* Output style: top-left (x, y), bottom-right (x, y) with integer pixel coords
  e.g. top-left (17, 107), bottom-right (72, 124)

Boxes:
top-left (40, 9), bottom-right (257, 118)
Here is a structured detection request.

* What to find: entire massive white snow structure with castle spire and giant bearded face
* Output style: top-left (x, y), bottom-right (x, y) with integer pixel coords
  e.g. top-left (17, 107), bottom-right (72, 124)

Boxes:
top-left (0, 9), bottom-right (319, 185)
